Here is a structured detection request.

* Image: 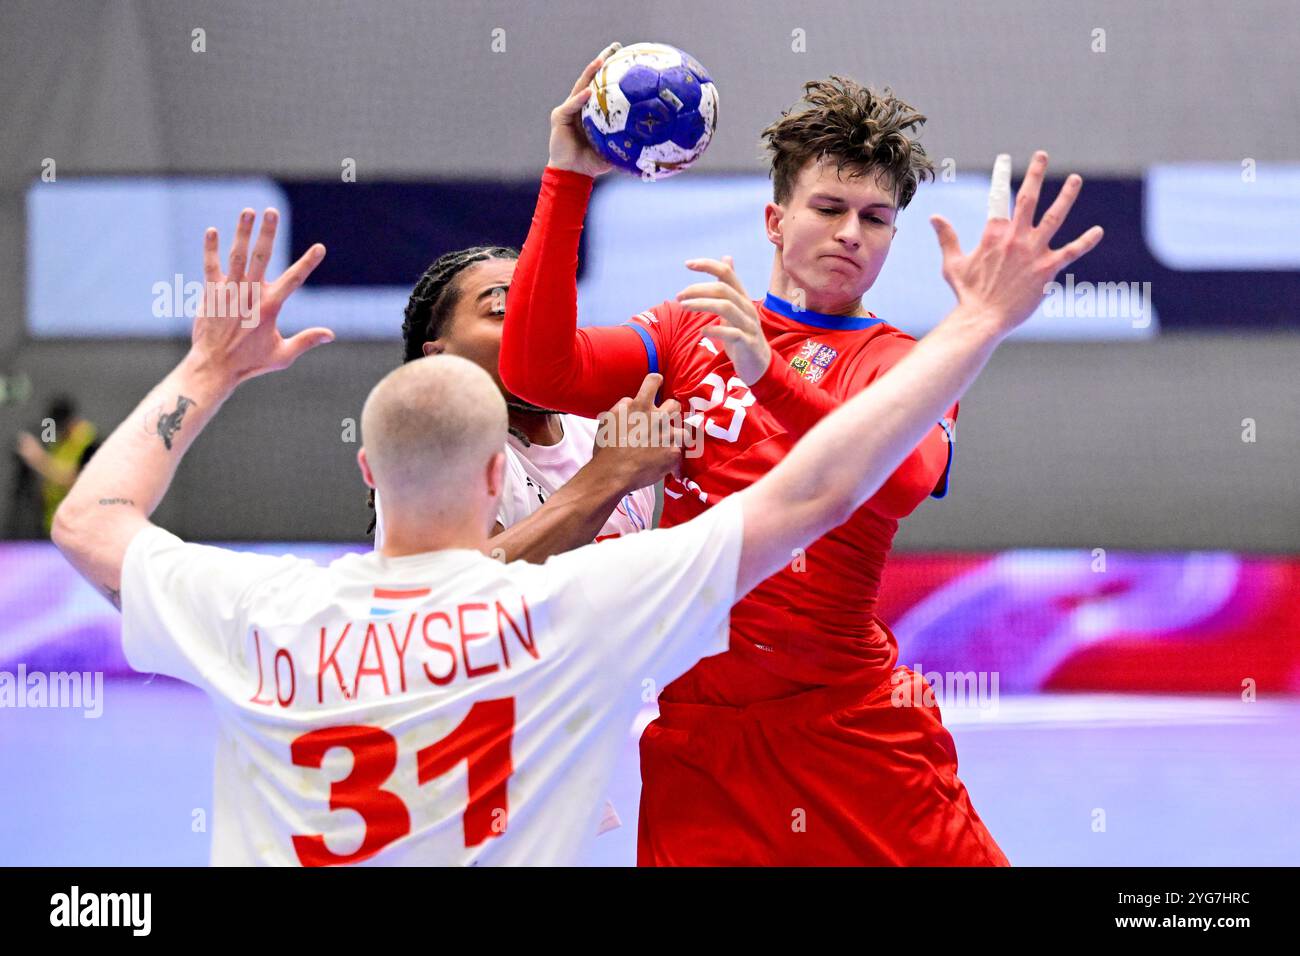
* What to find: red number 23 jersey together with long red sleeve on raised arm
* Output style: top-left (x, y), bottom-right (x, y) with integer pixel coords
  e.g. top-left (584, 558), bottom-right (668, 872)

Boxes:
top-left (501, 168), bottom-right (957, 705)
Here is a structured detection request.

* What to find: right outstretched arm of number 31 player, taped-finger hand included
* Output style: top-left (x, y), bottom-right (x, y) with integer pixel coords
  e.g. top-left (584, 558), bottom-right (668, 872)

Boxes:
top-left (737, 152), bottom-right (1101, 596)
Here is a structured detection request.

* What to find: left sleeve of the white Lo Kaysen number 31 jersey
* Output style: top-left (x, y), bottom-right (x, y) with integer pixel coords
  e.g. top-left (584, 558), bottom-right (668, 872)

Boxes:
top-left (122, 524), bottom-right (320, 687)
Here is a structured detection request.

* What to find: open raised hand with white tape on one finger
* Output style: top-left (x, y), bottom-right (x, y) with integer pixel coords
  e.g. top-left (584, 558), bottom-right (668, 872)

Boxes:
top-left (930, 150), bottom-right (1102, 333)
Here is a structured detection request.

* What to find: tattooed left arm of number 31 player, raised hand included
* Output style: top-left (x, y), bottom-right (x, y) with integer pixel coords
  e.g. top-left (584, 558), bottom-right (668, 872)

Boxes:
top-left (52, 209), bottom-right (333, 607)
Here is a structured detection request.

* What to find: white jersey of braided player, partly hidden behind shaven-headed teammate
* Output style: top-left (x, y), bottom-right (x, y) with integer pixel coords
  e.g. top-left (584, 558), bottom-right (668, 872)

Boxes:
top-left (499, 415), bottom-right (654, 548)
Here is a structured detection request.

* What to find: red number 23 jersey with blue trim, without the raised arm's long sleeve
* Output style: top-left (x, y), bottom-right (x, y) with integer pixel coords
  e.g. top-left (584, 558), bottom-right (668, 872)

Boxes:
top-left (618, 294), bottom-right (957, 704)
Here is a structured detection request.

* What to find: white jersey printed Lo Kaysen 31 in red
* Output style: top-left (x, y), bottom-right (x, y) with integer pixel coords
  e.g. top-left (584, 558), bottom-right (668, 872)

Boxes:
top-left (122, 498), bottom-right (742, 865)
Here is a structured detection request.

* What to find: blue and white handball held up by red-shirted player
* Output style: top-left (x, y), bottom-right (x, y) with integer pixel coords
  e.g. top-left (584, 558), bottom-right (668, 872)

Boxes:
top-left (582, 43), bottom-right (718, 181)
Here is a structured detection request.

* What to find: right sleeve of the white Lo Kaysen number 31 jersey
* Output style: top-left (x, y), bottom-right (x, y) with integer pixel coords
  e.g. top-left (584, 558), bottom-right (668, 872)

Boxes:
top-left (545, 496), bottom-right (744, 692)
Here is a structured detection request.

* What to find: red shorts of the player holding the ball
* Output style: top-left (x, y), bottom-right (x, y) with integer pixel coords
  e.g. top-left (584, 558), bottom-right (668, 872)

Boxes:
top-left (637, 667), bottom-right (1010, 866)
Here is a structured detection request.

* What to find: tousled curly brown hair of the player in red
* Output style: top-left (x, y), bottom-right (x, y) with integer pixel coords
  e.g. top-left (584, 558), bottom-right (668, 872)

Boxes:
top-left (762, 75), bottom-right (935, 211)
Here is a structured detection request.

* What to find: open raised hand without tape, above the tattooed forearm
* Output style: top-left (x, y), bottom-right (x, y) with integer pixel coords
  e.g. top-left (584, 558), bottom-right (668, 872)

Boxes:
top-left (191, 209), bottom-right (334, 385)
